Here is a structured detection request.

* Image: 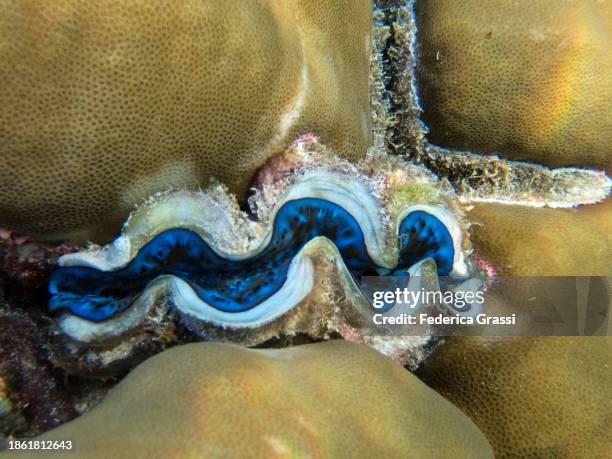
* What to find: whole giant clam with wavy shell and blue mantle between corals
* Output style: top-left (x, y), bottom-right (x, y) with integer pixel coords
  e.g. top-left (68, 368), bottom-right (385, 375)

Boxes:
top-left (44, 139), bottom-right (480, 378)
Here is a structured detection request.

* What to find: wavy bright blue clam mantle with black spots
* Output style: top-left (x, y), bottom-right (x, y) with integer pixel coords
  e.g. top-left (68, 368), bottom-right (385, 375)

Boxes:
top-left (49, 197), bottom-right (455, 321)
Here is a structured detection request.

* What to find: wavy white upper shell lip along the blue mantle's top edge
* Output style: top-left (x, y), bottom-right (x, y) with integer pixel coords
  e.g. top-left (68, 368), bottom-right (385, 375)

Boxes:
top-left (58, 170), bottom-right (468, 276)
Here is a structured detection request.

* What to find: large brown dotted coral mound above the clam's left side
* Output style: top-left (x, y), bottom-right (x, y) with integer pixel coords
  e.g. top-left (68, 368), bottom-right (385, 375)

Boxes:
top-left (0, 0), bottom-right (371, 244)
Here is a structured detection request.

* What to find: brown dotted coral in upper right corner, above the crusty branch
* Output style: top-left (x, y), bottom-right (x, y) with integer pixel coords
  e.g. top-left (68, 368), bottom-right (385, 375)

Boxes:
top-left (416, 0), bottom-right (612, 169)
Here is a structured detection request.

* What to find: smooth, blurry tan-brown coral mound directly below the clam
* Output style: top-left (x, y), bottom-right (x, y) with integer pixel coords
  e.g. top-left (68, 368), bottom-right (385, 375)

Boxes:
top-left (24, 341), bottom-right (492, 458)
